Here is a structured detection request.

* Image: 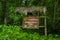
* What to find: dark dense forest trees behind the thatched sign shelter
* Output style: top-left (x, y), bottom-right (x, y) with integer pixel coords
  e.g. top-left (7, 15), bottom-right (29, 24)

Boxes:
top-left (0, 0), bottom-right (60, 39)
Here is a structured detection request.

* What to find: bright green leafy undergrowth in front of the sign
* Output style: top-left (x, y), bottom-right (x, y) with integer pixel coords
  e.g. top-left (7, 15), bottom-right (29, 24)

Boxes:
top-left (0, 25), bottom-right (60, 40)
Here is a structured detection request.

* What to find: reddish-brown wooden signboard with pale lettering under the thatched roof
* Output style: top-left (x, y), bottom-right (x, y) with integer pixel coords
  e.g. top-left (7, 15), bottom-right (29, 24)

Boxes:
top-left (22, 16), bottom-right (39, 29)
